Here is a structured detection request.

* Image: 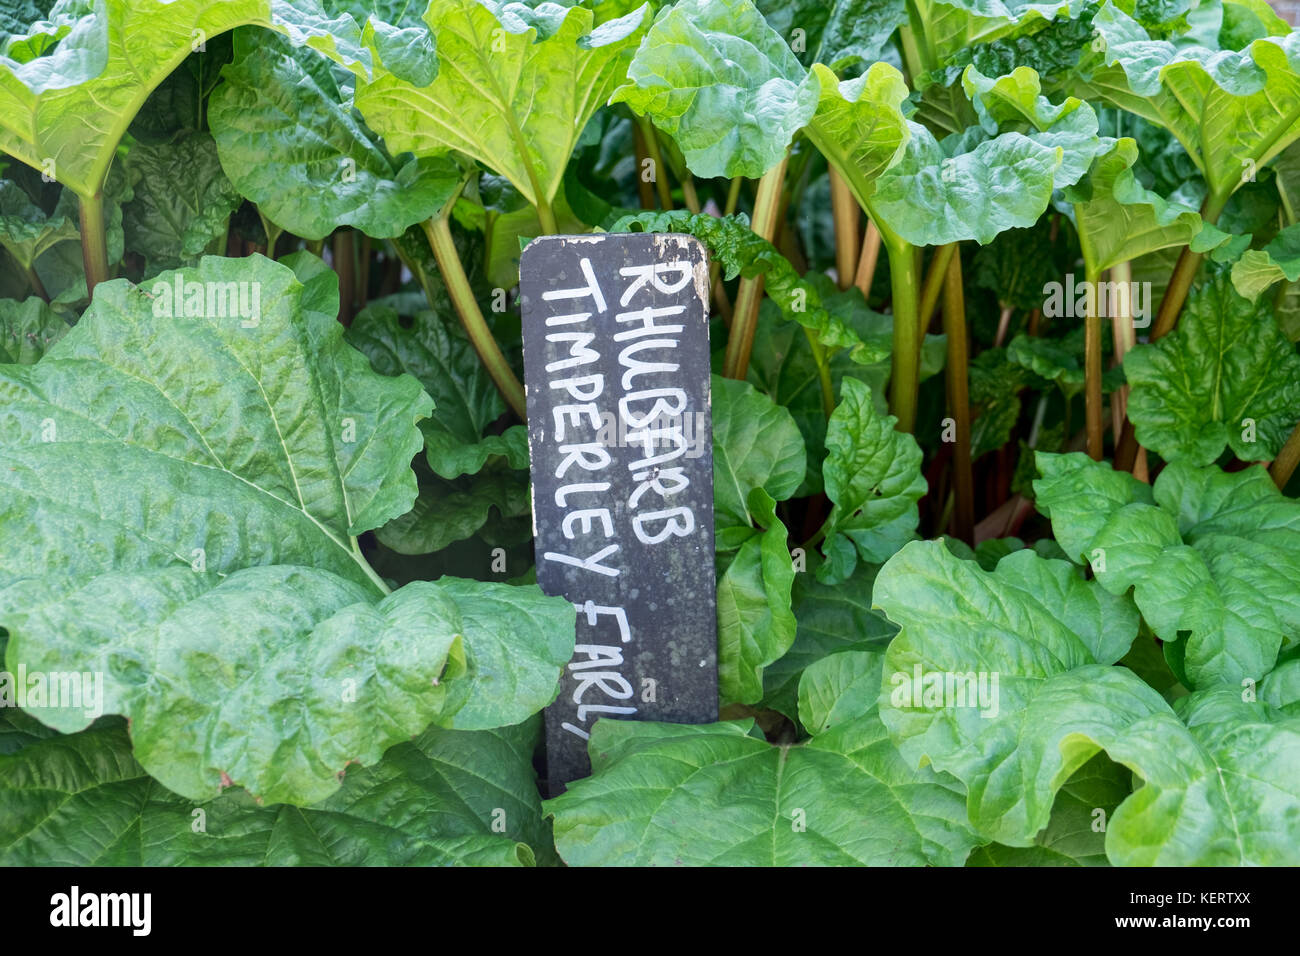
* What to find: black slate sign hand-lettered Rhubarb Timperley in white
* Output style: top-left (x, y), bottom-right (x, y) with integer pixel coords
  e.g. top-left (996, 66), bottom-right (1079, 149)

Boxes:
top-left (520, 233), bottom-right (718, 795)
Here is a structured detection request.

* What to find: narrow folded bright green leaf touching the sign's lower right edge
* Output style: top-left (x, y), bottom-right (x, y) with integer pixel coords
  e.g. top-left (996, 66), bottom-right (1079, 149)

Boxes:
top-left (718, 488), bottom-right (796, 705)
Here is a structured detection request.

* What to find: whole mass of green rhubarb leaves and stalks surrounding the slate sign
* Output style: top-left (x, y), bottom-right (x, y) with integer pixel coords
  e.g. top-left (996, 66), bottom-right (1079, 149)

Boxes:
top-left (0, 0), bottom-right (1300, 866)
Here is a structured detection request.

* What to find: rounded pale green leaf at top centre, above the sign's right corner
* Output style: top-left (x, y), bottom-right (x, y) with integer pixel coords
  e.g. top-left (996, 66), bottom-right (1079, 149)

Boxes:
top-left (612, 0), bottom-right (818, 178)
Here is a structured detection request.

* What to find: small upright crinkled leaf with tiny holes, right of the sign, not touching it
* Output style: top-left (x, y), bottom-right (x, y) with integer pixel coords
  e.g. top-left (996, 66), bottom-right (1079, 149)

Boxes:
top-left (818, 378), bottom-right (926, 584)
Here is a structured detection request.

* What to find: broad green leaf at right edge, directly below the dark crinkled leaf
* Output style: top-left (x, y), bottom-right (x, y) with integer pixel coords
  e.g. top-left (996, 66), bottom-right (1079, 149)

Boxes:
top-left (1034, 453), bottom-right (1300, 687)
